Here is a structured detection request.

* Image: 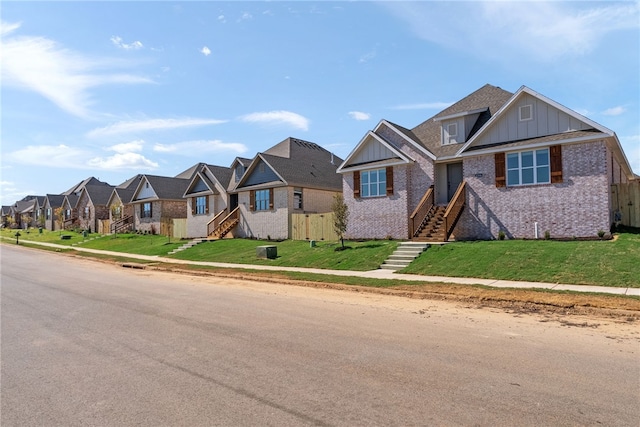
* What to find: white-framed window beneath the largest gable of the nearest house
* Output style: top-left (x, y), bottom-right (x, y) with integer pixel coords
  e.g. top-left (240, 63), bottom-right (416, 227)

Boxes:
top-left (507, 148), bottom-right (551, 186)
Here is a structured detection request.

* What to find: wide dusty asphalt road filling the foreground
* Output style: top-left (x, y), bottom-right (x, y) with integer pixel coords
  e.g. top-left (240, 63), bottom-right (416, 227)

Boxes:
top-left (0, 245), bottom-right (640, 427)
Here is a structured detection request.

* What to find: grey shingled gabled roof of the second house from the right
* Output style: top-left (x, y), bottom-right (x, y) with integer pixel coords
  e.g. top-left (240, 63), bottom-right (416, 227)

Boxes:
top-left (235, 137), bottom-right (342, 191)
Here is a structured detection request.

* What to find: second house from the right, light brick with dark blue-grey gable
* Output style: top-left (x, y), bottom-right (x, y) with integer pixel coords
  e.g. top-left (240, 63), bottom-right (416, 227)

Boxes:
top-left (224, 138), bottom-right (342, 239)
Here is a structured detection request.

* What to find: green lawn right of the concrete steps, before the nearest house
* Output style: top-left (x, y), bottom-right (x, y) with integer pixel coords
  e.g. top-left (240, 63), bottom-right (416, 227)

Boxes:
top-left (401, 233), bottom-right (640, 287)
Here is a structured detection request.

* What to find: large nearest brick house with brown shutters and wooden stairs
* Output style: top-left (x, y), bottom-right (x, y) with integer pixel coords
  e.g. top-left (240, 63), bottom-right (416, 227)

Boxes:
top-left (338, 85), bottom-right (635, 241)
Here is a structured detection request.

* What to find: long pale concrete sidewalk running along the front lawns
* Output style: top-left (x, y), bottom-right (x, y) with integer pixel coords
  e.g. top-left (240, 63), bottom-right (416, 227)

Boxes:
top-left (10, 240), bottom-right (640, 296)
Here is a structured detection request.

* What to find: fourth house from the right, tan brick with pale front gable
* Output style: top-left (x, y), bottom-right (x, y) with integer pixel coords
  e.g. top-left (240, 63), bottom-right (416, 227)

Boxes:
top-left (130, 175), bottom-right (191, 234)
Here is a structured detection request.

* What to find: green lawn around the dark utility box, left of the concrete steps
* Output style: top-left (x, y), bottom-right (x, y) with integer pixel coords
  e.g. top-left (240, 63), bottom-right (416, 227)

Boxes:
top-left (171, 239), bottom-right (398, 271)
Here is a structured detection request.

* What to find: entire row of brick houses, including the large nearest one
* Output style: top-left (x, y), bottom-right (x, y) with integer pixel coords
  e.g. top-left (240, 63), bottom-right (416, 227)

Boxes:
top-left (2, 84), bottom-right (640, 241)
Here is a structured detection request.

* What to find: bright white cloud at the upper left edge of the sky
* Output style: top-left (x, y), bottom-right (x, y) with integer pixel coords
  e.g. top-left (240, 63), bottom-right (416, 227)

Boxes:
top-left (0, 23), bottom-right (151, 118)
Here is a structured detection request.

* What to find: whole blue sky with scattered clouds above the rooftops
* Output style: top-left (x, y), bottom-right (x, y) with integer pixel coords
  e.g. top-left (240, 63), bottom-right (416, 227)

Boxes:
top-left (0, 1), bottom-right (640, 205)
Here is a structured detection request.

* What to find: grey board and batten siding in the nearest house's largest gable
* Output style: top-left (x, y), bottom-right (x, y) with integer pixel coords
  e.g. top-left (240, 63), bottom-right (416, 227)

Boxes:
top-left (474, 94), bottom-right (591, 146)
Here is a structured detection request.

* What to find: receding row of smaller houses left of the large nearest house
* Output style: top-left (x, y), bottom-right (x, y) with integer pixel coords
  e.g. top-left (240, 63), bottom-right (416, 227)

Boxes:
top-left (2, 138), bottom-right (342, 239)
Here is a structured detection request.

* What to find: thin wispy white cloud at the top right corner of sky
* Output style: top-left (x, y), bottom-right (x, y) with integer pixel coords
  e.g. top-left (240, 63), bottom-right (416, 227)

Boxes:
top-left (377, 1), bottom-right (640, 61)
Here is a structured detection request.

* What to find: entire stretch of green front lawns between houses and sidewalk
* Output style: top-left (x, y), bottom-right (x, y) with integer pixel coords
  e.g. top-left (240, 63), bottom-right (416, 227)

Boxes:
top-left (0, 229), bottom-right (640, 287)
